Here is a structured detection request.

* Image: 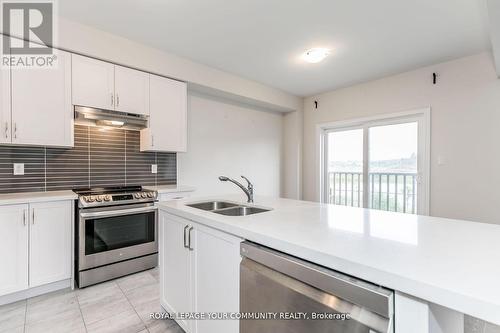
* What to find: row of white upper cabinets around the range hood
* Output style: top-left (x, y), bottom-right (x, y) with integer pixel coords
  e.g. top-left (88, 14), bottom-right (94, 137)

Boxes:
top-left (0, 49), bottom-right (187, 148)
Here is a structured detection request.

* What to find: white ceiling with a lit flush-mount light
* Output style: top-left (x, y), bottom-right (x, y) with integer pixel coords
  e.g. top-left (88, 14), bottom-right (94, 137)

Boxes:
top-left (58, 0), bottom-right (491, 96)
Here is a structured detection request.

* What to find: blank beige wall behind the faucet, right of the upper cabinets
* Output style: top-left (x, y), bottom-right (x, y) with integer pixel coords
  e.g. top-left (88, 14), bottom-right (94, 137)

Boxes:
top-left (177, 93), bottom-right (283, 199)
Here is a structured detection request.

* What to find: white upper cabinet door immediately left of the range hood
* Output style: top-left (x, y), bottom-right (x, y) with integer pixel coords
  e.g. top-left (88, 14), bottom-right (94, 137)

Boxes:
top-left (11, 50), bottom-right (73, 147)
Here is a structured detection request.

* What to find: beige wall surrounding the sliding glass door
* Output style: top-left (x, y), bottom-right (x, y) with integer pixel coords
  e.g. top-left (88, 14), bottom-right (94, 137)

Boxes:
top-left (303, 53), bottom-right (500, 224)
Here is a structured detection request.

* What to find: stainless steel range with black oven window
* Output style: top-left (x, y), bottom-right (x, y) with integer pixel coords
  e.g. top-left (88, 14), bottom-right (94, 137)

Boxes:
top-left (74, 186), bottom-right (158, 288)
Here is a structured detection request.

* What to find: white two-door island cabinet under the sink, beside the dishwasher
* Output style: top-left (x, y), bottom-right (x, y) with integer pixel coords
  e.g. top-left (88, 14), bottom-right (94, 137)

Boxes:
top-left (160, 211), bottom-right (242, 333)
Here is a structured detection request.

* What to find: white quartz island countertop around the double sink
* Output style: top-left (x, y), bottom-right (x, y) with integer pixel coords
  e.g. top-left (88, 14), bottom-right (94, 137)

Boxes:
top-left (158, 195), bottom-right (500, 325)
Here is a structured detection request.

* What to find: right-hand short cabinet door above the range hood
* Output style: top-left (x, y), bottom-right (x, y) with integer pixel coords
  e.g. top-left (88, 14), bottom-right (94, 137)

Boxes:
top-left (115, 66), bottom-right (149, 115)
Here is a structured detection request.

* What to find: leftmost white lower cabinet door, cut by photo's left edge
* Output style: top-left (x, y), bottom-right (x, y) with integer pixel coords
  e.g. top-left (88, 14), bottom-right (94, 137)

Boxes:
top-left (0, 205), bottom-right (28, 296)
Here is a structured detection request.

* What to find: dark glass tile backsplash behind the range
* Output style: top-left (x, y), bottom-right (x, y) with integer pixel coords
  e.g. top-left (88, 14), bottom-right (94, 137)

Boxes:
top-left (0, 125), bottom-right (177, 193)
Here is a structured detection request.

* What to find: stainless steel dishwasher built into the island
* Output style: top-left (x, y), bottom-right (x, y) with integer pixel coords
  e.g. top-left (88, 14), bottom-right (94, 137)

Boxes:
top-left (240, 242), bottom-right (394, 333)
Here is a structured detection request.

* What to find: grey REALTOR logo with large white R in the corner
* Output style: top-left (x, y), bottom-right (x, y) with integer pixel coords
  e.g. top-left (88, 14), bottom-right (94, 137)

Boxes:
top-left (2, 0), bottom-right (55, 67)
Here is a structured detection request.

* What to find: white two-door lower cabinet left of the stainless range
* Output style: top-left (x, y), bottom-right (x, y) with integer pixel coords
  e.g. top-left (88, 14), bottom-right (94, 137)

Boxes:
top-left (0, 201), bottom-right (72, 296)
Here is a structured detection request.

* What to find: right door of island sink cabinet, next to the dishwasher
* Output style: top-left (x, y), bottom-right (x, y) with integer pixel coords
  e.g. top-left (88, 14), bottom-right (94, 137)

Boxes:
top-left (191, 224), bottom-right (242, 333)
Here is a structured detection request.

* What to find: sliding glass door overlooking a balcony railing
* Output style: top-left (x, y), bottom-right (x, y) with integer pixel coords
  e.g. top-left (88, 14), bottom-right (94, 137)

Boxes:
top-left (322, 111), bottom-right (428, 214)
